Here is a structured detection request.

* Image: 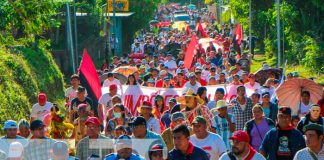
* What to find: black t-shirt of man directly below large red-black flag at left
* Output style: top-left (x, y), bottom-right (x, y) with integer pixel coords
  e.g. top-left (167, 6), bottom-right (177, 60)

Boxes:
top-left (70, 97), bottom-right (98, 121)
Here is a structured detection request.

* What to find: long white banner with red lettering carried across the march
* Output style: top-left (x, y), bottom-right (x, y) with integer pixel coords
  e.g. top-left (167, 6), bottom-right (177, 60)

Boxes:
top-left (102, 84), bottom-right (246, 115)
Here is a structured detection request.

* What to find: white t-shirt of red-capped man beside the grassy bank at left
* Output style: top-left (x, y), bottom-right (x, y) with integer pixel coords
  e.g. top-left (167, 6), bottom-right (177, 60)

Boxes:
top-left (30, 102), bottom-right (53, 121)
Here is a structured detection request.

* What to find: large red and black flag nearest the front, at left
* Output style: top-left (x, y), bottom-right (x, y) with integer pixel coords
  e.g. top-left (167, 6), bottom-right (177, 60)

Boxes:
top-left (79, 49), bottom-right (101, 102)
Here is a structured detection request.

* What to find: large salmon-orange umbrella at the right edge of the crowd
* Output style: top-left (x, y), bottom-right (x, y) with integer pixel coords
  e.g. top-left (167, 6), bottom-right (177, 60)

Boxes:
top-left (276, 78), bottom-right (322, 114)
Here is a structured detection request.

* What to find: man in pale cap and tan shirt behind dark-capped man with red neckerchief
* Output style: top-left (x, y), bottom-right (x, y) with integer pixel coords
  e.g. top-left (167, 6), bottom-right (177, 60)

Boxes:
top-left (161, 112), bottom-right (193, 151)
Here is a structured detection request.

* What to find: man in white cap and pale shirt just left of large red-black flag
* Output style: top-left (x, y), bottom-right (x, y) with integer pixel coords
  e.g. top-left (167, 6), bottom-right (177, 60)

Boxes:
top-left (65, 74), bottom-right (87, 107)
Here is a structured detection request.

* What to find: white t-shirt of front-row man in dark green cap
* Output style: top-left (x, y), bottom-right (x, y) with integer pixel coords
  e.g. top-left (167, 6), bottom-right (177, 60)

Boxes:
top-left (190, 132), bottom-right (226, 160)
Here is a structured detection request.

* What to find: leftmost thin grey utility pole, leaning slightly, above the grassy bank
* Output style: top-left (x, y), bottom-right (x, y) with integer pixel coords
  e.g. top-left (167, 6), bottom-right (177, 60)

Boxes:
top-left (66, 3), bottom-right (76, 73)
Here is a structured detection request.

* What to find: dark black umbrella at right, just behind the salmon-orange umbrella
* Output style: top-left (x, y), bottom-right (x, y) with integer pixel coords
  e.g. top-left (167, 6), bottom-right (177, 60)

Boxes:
top-left (254, 68), bottom-right (282, 85)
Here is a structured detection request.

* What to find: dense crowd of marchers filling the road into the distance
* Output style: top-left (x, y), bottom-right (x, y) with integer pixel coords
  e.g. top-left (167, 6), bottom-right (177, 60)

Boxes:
top-left (0, 2), bottom-right (324, 160)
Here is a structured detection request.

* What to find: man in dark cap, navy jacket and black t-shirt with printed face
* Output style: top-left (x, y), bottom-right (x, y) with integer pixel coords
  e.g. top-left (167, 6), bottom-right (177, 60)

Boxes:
top-left (259, 107), bottom-right (306, 160)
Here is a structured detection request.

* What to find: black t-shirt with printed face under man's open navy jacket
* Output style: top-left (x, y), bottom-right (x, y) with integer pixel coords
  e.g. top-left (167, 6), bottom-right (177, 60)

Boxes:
top-left (277, 130), bottom-right (294, 160)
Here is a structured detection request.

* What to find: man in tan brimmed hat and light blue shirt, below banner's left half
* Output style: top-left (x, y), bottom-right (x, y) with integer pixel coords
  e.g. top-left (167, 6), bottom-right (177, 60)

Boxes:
top-left (138, 101), bottom-right (161, 134)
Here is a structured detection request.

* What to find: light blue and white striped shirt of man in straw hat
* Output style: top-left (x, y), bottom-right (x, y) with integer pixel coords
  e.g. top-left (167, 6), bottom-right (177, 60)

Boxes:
top-left (214, 114), bottom-right (235, 150)
